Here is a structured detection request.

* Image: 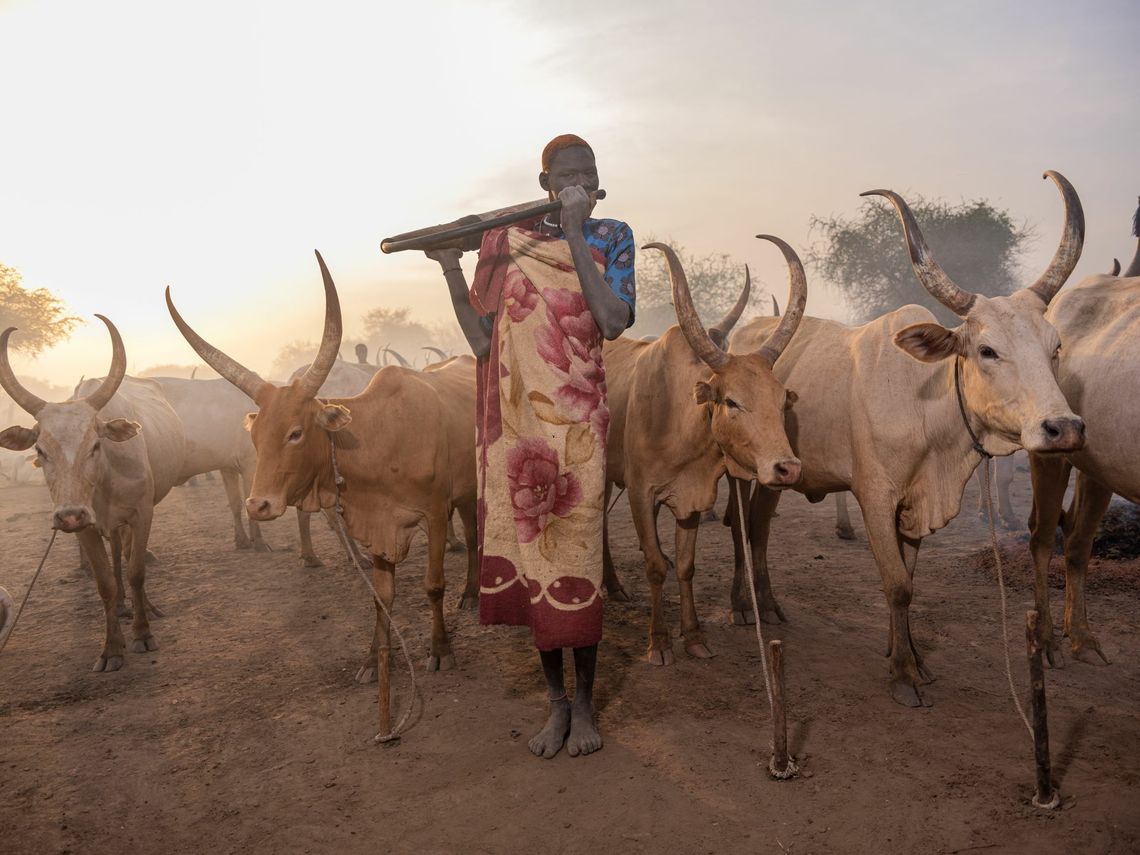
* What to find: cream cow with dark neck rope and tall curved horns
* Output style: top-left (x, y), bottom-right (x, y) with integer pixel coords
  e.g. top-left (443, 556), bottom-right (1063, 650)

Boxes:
top-left (732, 172), bottom-right (1084, 706)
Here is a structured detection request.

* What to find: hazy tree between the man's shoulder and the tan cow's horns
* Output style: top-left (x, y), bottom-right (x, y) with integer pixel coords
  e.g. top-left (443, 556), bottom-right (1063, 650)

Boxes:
top-left (632, 237), bottom-right (756, 336)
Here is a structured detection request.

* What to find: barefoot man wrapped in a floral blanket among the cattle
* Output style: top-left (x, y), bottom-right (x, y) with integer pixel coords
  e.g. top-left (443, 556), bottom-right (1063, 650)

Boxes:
top-left (428, 133), bottom-right (634, 758)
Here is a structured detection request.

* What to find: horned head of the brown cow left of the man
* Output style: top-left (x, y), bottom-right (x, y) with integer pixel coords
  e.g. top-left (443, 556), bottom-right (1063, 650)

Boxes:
top-left (166, 252), bottom-right (351, 521)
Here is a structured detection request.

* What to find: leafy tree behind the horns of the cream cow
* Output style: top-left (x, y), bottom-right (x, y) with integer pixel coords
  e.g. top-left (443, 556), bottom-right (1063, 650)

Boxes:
top-left (807, 197), bottom-right (1033, 326)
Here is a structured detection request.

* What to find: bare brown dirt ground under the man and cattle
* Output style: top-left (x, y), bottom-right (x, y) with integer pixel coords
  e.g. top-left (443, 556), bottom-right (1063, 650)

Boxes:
top-left (0, 473), bottom-right (1140, 855)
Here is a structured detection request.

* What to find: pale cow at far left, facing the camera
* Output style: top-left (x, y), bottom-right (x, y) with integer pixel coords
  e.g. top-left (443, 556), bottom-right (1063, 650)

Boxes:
top-left (0, 315), bottom-right (185, 671)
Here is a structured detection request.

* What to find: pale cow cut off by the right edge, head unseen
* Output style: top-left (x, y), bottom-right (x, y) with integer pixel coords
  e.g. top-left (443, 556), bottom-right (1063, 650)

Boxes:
top-left (1029, 199), bottom-right (1140, 662)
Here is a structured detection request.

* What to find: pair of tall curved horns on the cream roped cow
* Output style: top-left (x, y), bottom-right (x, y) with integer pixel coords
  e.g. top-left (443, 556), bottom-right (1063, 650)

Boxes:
top-left (860, 170), bottom-right (1084, 318)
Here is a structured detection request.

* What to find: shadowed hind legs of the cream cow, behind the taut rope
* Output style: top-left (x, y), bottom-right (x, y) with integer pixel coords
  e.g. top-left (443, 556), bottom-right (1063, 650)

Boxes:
top-left (728, 481), bottom-right (787, 626)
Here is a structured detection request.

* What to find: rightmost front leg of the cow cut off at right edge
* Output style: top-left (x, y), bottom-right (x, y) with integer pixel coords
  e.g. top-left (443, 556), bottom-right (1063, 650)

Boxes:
top-left (1064, 472), bottom-right (1113, 665)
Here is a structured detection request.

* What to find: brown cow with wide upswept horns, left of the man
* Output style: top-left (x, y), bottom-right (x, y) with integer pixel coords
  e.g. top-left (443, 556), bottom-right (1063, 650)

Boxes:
top-left (166, 253), bottom-right (479, 733)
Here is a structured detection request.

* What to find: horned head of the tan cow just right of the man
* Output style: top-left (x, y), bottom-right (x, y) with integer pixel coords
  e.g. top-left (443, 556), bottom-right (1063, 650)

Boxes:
top-left (646, 241), bottom-right (807, 489)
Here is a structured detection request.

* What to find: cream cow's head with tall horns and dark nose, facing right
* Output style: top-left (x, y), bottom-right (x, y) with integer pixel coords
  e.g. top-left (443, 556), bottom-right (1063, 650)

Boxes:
top-left (863, 171), bottom-right (1084, 455)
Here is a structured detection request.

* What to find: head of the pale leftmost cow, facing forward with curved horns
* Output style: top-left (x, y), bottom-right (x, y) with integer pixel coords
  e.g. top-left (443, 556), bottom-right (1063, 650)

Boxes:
top-left (0, 315), bottom-right (140, 531)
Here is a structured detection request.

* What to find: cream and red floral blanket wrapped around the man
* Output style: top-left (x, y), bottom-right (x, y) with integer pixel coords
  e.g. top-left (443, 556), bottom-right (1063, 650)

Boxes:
top-left (471, 221), bottom-right (610, 650)
